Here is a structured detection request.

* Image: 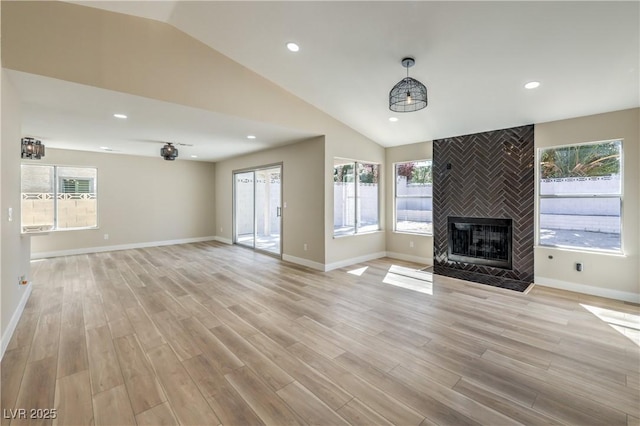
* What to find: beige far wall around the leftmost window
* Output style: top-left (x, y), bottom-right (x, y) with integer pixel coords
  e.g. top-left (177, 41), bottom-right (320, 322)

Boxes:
top-left (30, 148), bottom-right (216, 258)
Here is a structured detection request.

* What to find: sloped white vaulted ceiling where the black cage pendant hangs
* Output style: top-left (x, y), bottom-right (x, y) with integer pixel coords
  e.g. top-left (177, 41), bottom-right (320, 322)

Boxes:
top-left (169, 1), bottom-right (640, 146)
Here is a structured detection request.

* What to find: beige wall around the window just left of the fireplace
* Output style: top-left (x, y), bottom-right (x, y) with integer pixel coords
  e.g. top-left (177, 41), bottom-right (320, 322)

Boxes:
top-left (384, 142), bottom-right (433, 265)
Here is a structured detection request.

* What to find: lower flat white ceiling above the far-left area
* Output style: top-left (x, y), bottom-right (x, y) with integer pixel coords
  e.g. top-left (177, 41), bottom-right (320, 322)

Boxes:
top-left (8, 70), bottom-right (315, 161)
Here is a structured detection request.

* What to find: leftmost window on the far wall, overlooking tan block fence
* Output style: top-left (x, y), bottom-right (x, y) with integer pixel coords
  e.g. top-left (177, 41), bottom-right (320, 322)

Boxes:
top-left (21, 164), bottom-right (98, 232)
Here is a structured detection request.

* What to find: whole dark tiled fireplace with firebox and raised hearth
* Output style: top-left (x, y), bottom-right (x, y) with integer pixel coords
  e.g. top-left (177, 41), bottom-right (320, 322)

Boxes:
top-left (433, 125), bottom-right (534, 291)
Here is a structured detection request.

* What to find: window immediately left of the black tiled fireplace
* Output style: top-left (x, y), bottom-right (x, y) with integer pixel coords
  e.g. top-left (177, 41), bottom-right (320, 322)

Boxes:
top-left (395, 160), bottom-right (433, 234)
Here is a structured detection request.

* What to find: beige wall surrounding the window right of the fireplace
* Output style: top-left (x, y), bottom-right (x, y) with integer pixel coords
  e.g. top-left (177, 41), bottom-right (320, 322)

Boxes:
top-left (535, 108), bottom-right (640, 303)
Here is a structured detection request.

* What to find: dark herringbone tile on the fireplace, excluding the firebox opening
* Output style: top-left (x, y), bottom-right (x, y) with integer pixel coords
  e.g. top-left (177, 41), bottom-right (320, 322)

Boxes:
top-left (433, 125), bottom-right (535, 290)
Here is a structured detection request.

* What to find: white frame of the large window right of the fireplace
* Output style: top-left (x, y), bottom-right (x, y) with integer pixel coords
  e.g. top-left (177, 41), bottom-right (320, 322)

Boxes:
top-left (535, 138), bottom-right (624, 255)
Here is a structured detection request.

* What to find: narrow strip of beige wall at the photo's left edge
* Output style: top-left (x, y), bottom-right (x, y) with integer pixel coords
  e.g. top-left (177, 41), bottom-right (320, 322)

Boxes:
top-left (0, 69), bottom-right (31, 355)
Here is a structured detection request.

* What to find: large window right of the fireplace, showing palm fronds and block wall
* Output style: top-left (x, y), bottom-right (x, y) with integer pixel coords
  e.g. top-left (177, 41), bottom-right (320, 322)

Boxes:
top-left (538, 140), bottom-right (622, 252)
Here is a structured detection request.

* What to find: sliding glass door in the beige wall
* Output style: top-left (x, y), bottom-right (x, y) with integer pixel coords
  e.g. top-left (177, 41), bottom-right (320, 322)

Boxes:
top-left (234, 165), bottom-right (282, 256)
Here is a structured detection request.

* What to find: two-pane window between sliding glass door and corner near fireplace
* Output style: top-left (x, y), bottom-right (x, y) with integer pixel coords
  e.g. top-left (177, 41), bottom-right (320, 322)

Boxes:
top-left (333, 159), bottom-right (380, 236)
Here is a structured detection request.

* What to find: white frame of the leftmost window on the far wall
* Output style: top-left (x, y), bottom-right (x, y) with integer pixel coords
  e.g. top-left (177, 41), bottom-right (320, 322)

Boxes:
top-left (20, 162), bottom-right (100, 235)
